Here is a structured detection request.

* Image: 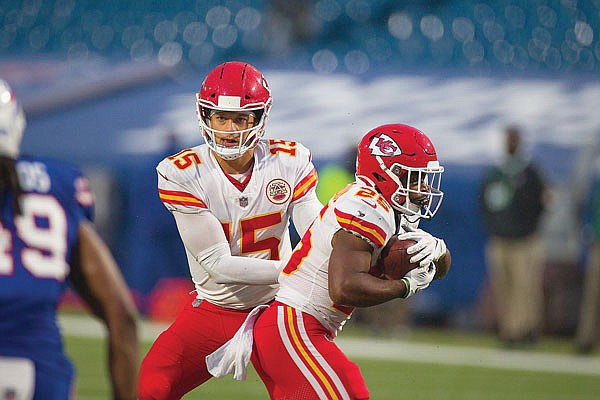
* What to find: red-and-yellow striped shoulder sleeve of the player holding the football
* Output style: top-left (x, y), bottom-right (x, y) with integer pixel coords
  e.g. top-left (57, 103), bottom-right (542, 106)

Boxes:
top-left (332, 187), bottom-right (395, 249)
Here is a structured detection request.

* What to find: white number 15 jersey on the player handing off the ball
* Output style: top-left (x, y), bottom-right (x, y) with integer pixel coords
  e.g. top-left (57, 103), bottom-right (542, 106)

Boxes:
top-left (157, 139), bottom-right (317, 309)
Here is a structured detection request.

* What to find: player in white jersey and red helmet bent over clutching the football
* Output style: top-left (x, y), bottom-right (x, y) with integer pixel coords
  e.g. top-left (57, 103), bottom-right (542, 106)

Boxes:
top-left (252, 124), bottom-right (450, 400)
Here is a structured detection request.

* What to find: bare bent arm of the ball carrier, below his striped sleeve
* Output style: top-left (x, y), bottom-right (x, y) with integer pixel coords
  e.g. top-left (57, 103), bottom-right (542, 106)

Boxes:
top-left (329, 230), bottom-right (407, 307)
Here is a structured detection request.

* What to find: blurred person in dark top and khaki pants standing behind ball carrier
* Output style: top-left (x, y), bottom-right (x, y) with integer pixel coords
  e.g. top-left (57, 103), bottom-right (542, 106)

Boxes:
top-left (480, 126), bottom-right (547, 347)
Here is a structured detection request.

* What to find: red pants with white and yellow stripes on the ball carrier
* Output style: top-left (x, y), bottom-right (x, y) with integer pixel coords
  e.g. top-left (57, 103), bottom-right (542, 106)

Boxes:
top-left (253, 302), bottom-right (369, 400)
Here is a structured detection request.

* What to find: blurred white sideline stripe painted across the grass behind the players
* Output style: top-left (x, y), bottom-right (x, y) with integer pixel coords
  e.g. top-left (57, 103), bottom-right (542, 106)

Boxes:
top-left (58, 314), bottom-right (600, 375)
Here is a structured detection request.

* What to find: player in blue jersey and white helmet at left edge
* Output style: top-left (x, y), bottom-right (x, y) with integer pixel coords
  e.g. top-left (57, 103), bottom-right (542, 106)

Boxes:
top-left (0, 80), bottom-right (138, 400)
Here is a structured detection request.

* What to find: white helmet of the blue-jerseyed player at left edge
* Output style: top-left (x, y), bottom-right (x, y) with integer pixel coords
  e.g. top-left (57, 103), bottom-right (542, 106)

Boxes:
top-left (0, 79), bottom-right (26, 158)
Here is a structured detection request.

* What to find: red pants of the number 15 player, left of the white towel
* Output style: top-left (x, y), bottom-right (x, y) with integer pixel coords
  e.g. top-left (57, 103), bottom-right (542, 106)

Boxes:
top-left (138, 294), bottom-right (251, 400)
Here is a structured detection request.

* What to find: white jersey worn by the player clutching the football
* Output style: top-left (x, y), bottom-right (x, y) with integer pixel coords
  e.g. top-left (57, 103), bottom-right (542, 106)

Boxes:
top-left (276, 183), bottom-right (418, 334)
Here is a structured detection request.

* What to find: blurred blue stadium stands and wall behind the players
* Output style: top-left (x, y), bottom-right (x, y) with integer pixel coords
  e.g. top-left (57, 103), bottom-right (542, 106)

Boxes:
top-left (0, 0), bottom-right (600, 334)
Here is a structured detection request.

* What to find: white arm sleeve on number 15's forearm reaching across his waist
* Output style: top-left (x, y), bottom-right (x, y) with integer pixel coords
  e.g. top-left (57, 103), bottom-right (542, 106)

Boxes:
top-left (173, 211), bottom-right (281, 285)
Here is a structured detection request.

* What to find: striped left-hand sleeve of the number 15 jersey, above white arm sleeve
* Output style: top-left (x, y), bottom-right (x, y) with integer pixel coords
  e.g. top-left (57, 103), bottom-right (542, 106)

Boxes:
top-left (156, 152), bottom-right (208, 214)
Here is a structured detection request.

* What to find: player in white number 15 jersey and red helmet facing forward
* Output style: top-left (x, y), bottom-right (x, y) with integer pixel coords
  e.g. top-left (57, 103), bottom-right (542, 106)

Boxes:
top-left (138, 62), bottom-right (323, 400)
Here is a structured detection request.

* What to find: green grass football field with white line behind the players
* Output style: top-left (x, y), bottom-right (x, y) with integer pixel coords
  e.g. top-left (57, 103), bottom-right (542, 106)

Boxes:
top-left (65, 316), bottom-right (600, 400)
